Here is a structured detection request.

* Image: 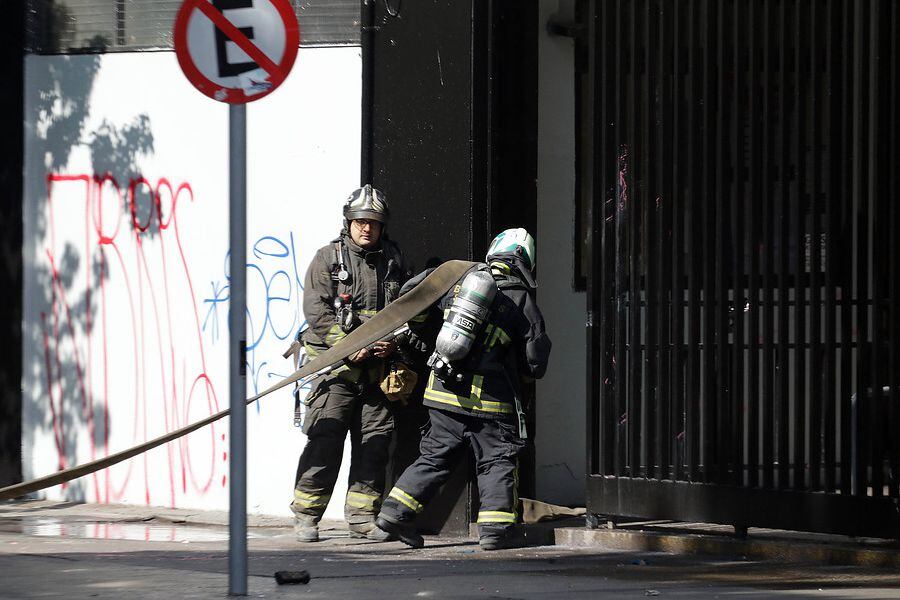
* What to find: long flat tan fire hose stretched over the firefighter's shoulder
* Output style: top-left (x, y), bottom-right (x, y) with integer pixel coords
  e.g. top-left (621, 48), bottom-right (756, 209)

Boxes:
top-left (0, 260), bottom-right (476, 500)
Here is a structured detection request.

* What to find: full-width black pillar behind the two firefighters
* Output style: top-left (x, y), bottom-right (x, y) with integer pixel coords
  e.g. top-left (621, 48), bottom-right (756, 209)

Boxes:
top-left (362, 0), bottom-right (537, 533)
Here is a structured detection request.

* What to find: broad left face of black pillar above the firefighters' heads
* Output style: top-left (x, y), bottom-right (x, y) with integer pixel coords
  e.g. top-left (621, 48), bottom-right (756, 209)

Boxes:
top-left (371, 0), bottom-right (485, 269)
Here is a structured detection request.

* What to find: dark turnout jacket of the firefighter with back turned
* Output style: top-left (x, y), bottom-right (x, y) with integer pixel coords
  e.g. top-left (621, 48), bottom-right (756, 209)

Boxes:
top-left (400, 264), bottom-right (551, 419)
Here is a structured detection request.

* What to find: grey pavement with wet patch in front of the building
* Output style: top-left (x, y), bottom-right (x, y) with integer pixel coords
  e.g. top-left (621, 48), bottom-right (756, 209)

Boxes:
top-left (0, 501), bottom-right (900, 600)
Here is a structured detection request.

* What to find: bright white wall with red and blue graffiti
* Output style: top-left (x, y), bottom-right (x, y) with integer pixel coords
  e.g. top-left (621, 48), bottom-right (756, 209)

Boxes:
top-left (22, 48), bottom-right (361, 516)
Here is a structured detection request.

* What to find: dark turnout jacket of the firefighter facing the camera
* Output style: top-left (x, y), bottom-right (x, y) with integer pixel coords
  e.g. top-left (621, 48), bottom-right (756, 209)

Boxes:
top-left (302, 229), bottom-right (409, 383)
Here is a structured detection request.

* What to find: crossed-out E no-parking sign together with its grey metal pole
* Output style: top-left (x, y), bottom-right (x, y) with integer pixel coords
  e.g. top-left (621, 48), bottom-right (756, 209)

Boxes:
top-left (174, 0), bottom-right (300, 596)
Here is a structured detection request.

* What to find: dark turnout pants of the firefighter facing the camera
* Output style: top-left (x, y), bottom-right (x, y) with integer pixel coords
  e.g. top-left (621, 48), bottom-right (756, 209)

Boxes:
top-left (291, 377), bottom-right (394, 525)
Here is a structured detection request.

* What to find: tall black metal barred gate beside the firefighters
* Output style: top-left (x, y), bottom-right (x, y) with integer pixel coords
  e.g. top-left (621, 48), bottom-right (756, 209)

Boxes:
top-left (585, 0), bottom-right (900, 537)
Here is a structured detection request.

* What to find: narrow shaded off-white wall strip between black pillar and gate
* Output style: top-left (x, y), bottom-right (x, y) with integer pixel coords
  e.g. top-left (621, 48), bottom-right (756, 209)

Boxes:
top-left (536, 0), bottom-right (587, 506)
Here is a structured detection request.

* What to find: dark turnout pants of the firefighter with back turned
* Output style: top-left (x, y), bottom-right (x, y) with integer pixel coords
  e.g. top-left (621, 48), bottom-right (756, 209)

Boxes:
top-left (381, 408), bottom-right (526, 528)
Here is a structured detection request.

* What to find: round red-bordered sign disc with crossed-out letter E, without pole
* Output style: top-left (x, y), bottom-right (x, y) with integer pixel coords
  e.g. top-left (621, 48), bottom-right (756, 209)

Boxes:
top-left (174, 0), bottom-right (300, 104)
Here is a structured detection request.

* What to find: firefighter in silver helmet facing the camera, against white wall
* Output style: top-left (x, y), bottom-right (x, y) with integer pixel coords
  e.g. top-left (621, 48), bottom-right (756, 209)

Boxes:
top-left (291, 185), bottom-right (409, 542)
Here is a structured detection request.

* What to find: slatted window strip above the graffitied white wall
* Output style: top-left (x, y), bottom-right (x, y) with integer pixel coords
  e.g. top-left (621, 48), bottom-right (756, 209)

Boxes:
top-left (25, 0), bottom-right (360, 54)
